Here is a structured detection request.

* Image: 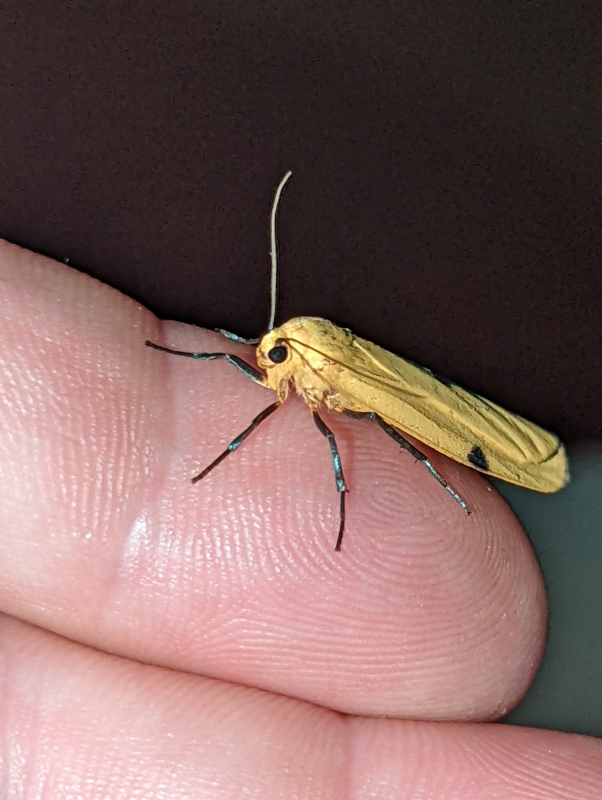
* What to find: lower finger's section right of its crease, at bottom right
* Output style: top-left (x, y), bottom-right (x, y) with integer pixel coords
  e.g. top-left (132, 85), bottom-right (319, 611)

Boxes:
top-left (348, 718), bottom-right (602, 800)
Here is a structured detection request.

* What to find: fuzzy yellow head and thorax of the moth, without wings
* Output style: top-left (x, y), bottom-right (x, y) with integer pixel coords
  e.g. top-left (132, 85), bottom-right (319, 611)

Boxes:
top-left (256, 317), bottom-right (353, 409)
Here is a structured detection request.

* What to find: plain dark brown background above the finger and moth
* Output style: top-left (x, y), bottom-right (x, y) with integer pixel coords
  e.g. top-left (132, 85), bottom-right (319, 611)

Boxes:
top-left (0, 0), bottom-right (602, 442)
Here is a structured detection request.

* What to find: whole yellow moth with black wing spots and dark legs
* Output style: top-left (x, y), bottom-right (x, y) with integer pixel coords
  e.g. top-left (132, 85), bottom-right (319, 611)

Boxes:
top-left (146, 172), bottom-right (569, 550)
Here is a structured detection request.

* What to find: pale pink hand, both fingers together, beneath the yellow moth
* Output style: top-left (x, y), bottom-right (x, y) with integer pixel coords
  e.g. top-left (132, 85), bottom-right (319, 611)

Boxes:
top-left (0, 243), bottom-right (602, 800)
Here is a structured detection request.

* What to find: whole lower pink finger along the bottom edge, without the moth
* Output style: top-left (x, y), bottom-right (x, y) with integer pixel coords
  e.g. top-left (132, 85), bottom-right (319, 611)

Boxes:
top-left (0, 616), bottom-right (602, 800)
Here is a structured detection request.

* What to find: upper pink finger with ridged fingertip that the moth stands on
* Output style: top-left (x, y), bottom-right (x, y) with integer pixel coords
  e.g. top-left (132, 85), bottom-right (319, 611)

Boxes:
top-left (0, 243), bottom-right (546, 720)
